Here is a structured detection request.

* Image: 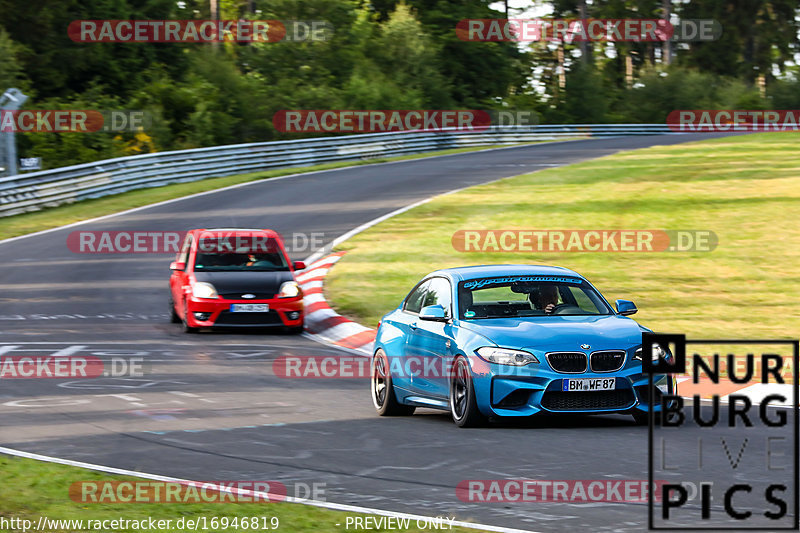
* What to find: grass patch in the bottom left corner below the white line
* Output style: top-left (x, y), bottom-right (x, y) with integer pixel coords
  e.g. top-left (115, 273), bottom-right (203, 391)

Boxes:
top-left (0, 455), bottom-right (476, 533)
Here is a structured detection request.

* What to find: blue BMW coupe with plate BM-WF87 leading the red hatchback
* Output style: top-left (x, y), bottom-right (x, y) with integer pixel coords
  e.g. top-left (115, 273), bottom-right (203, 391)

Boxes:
top-left (370, 265), bottom-right (677, 427)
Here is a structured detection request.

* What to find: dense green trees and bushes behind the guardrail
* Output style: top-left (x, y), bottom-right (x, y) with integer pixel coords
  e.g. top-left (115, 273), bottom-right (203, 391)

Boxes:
top-left (0, 0), bottom-right (800, 167)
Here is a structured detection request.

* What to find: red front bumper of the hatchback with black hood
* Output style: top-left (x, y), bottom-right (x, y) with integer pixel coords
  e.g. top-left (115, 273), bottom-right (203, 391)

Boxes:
top-left (186, 297), bottom-right (303, 328)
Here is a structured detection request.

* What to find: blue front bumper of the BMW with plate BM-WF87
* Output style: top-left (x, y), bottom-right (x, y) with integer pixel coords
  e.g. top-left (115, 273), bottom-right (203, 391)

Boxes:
top-left (473, 360), bottom-right (677, 416)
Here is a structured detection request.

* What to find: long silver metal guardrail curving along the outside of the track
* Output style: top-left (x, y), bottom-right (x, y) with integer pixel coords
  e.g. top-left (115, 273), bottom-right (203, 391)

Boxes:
top-left (0, 124), bottom-right (675, 217)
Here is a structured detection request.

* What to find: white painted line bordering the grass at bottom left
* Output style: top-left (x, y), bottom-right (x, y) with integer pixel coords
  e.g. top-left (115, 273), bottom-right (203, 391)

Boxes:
top-left (0, 447), bottom-right (535, 533)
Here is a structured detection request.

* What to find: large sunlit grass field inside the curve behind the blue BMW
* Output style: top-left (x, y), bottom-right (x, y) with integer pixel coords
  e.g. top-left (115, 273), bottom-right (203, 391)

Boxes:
top-left (326, 133), bottom-right (800, 338)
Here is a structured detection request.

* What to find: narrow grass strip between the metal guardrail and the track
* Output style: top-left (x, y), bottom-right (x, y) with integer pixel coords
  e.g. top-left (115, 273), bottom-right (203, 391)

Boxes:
top-left (0, 138), bottom-right (573, 240)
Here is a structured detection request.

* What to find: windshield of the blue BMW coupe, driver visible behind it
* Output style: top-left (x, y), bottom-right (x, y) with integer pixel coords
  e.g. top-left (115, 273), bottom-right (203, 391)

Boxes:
top-left (458, 276), bottom-right (613, 320)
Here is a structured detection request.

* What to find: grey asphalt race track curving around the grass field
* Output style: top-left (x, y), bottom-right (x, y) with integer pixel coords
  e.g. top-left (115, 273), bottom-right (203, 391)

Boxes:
top-left (0, 135), bottom-right (792, 531)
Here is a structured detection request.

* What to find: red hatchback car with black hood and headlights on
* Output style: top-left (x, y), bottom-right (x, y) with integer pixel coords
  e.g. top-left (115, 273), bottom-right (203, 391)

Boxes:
top-left (169, 228), bottom-right (305, 333)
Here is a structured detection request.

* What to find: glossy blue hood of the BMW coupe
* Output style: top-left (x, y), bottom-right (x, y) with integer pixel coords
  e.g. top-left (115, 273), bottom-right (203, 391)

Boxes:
top-left (459, 315), bottom-right (642, 351)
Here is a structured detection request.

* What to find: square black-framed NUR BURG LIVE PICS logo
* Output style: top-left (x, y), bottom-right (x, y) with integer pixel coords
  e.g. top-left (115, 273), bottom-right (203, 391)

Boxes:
top-left (642, 333), bottom-right (800, 531)
